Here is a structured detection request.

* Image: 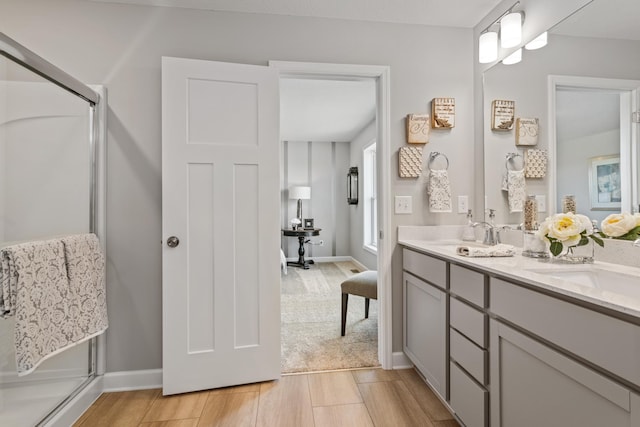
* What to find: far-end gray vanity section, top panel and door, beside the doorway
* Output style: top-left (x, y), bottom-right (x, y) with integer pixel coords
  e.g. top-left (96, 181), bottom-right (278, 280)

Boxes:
top-left (402, 249), bottom-right (447, 400)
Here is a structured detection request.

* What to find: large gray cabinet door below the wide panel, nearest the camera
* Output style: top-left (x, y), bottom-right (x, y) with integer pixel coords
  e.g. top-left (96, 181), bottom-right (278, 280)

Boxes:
top-left (490, 319), bottom-right (638, 427)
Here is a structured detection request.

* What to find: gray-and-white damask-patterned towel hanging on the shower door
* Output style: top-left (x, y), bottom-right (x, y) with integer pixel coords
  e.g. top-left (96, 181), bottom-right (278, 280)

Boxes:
top-left (0, 234), bottom-right (108, 376)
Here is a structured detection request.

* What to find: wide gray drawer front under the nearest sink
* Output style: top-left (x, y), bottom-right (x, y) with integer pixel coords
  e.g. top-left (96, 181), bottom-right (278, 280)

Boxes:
top-left (492, 278), bottom-right (640, 386)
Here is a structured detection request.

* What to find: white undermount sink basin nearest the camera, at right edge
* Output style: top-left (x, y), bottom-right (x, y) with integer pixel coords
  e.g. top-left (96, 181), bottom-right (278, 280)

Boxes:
top-left (527, 265), bottom-right (640, 298)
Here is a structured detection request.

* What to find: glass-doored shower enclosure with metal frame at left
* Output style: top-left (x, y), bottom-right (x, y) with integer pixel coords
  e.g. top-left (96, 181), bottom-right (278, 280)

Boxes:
top-left (0, 33), bottom-right (105, 427)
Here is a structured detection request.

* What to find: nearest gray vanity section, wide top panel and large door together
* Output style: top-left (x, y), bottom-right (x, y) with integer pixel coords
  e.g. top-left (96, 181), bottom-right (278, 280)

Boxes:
top-left (490, 278), bottom-right (640, 427)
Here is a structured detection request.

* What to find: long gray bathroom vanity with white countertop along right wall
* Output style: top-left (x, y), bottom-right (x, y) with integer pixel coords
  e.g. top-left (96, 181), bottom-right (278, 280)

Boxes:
top-left (399, 227), bottom-right (640, 427)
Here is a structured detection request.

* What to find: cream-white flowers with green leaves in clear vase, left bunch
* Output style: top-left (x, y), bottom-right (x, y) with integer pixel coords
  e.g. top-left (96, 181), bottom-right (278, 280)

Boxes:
top-left (536, 212), bottom-right (604, 256)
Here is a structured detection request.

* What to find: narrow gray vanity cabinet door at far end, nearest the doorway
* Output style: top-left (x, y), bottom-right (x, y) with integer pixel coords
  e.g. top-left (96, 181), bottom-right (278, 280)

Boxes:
top-left (403, 272), bottom-right (447, 399)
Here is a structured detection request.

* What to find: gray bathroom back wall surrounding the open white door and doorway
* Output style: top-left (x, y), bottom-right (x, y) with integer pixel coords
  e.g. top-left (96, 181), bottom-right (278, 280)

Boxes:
top-left (0, 0), bottom-right (474, 372)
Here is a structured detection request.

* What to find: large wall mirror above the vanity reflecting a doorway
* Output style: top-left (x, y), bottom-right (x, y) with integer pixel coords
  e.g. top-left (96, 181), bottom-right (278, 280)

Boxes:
top-left (483, 0), bottom-right (640, 224)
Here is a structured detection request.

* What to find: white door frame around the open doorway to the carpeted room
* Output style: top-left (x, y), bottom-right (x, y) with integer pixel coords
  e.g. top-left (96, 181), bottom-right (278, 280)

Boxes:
top-left (269, 61), bottom-right (393, 369)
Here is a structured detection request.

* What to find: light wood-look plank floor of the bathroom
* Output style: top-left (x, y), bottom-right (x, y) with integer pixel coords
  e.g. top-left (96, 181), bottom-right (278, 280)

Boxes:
top-left (74, 369), bottom-right (458, 427)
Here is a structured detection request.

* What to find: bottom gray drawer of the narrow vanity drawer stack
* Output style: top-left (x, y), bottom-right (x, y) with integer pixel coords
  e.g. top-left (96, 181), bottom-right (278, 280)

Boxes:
top-left (449, 363), bottom-right (489, 427)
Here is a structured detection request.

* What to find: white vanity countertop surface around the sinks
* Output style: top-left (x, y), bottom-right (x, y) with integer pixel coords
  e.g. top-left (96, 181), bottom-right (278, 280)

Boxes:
top-left (398, 237), bottom-right (640, 318)
